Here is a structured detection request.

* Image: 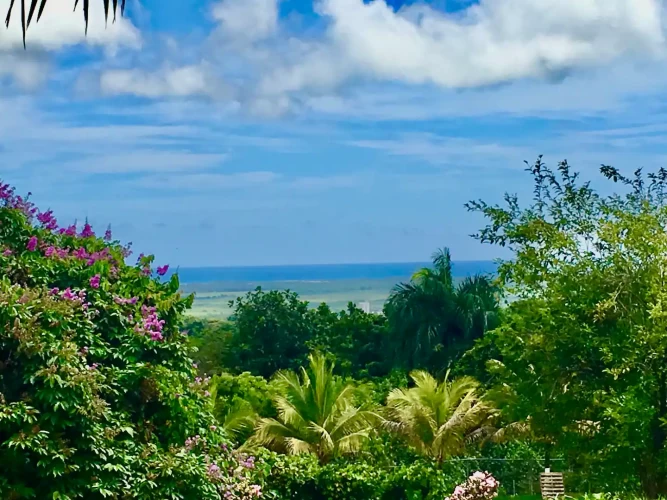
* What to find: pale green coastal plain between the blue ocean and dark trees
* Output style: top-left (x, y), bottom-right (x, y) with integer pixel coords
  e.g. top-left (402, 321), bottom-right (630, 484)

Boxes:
top-left (181, 278), bottom-right (401, 319)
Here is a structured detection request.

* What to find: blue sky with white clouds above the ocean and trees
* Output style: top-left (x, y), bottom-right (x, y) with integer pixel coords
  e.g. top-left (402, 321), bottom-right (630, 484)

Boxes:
top-left (0, 0), bottom-right (667, 267)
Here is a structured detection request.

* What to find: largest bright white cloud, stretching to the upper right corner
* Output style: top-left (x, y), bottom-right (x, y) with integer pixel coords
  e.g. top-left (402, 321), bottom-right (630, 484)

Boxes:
top-left (261, 0), bottom-right (665, 93)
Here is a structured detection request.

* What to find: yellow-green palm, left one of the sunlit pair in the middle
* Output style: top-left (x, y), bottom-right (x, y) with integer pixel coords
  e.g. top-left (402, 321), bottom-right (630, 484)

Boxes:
top-left (250, 355), bottom-right (375, 463)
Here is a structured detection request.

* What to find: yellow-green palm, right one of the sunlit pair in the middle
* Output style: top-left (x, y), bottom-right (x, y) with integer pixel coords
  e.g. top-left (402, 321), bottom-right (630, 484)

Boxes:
top-left (384, 370), bottom-right (497, 462)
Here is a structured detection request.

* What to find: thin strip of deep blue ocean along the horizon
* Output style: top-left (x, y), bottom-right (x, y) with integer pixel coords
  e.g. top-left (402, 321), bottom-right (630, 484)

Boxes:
top-left (174, 261), bottom-right (497, 285)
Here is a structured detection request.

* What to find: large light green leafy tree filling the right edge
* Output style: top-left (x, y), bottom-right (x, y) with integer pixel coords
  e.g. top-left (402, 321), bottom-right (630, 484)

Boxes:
top-left (469, 159), bottom-right (667, 496)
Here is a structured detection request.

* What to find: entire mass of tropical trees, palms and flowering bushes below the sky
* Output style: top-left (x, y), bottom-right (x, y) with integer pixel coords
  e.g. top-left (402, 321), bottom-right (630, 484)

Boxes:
top-left (0, 155), bottom-right (667, 500)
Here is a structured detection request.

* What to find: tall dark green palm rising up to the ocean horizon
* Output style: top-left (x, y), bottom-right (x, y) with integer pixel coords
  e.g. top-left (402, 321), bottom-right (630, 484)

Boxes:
top-left (385, 248), bottom-right (499, 369)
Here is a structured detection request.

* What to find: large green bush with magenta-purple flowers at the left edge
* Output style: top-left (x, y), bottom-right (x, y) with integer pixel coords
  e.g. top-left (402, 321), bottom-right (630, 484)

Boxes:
top-left (0, 182), bottom-right (261, 499)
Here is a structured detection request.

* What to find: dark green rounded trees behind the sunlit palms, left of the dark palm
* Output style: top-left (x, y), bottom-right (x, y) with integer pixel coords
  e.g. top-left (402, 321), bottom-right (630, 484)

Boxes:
top-left (226, 288), bottom-right (391, 378)
